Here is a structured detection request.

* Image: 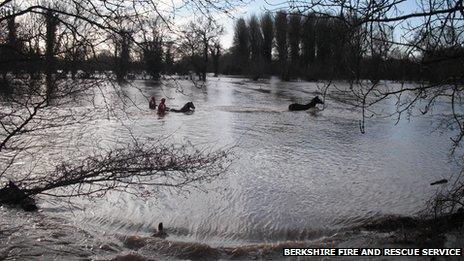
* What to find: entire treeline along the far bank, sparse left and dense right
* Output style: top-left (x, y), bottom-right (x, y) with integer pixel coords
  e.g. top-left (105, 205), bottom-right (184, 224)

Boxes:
top-left (0, 11), bottom-right (464, 83)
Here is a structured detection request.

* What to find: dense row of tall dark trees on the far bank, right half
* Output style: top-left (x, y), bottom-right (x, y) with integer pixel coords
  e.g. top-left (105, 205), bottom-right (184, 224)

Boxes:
top-left (222, 11), bottom-right (464, 81)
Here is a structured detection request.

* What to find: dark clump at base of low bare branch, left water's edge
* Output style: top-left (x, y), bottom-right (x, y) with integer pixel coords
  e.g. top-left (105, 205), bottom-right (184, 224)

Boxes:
top-left (0, 181), bottom-right (37, 211)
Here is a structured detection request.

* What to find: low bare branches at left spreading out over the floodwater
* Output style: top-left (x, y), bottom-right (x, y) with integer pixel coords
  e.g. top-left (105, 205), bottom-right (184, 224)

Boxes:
top-left (0, 70), bottom-right (230, 207)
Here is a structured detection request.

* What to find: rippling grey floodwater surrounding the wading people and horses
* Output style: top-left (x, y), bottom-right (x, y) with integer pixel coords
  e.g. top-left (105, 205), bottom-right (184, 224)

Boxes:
top-left (0, 77), bottom-right (458, 260)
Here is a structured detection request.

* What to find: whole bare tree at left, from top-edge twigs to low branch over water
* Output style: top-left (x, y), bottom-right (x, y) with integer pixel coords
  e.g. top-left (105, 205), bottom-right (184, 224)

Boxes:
top-left (0, 0), bottom-right (237, 209)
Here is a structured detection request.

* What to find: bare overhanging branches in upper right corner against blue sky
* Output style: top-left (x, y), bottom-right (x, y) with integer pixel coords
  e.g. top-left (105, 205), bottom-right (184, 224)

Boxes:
top-left (280, 0), bottom-right (464, 141)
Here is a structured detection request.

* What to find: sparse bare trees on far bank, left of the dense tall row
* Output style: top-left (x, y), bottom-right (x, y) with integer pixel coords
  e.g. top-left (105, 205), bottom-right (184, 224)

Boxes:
top-left (0, 11), bottom-right (222, 84)
